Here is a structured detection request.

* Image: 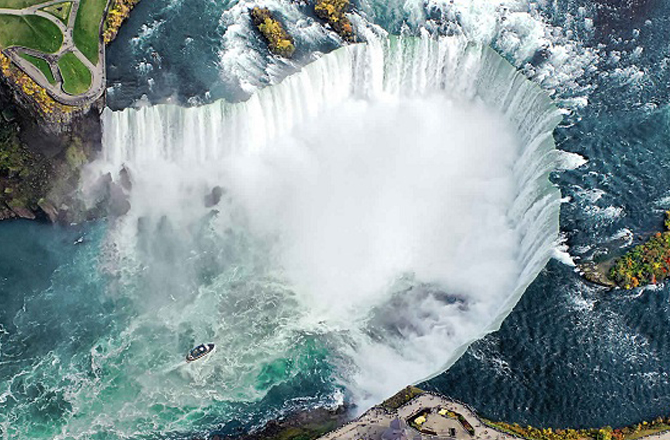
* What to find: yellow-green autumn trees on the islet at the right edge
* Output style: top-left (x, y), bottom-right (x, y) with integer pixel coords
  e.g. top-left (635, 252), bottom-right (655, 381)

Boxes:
top-left (609, 211), bottom-right (670, 289)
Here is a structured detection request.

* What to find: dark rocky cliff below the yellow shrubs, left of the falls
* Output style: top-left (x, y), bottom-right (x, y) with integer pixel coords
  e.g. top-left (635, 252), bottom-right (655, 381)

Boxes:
top-left (0, 77), bottom-right (101, 222)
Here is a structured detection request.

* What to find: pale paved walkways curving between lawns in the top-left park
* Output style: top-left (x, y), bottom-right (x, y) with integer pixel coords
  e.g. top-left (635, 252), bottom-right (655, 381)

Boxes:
top-left (0, 0), bottom-right (111, 106)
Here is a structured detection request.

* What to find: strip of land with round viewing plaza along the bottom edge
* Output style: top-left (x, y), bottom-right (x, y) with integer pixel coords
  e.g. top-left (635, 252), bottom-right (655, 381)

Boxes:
top-left (213, 386), bottom-right (670, 440)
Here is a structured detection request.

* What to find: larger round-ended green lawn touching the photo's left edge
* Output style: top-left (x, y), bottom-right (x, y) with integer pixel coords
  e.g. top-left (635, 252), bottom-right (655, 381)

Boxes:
top-left (0, 14), bottom-right (63, 53)
